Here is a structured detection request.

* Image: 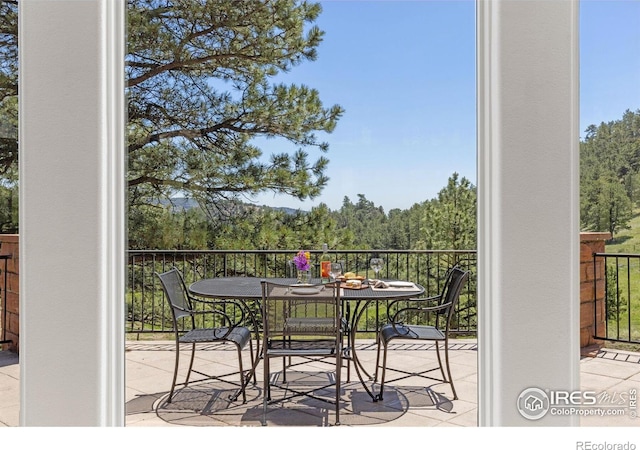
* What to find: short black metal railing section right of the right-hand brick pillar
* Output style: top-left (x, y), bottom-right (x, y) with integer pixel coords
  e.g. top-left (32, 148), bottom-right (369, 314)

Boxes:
top-left (593, 253), bottom-right (640, 344)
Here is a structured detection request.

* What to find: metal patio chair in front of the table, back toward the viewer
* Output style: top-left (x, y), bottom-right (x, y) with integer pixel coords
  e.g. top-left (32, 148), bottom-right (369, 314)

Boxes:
top-left (262, 280), bottom-right (342, 425)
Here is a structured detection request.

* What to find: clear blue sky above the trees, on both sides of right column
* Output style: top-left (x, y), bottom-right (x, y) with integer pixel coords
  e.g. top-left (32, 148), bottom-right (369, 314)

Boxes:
top-left (256, 0), bottom-right (640, 211)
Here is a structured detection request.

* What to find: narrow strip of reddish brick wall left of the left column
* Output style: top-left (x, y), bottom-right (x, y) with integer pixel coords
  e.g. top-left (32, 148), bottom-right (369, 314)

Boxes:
top-left (0, 234), bottom-right (20, 352)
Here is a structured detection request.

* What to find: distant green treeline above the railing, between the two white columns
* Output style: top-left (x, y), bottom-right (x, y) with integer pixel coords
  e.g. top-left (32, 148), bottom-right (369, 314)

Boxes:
top-left (129, 173), bottom-right (477, 250)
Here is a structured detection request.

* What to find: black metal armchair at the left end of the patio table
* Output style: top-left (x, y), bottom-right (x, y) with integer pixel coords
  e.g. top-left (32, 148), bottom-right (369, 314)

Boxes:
top-left (156, 267), bottom-right (258, 403)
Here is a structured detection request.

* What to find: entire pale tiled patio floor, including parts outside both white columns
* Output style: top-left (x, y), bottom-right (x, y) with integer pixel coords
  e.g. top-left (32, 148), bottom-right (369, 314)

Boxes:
top-left (0, 339), bottom-right (640, 427)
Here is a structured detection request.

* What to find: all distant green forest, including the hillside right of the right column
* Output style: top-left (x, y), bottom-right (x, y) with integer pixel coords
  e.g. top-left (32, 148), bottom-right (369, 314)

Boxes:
top-left (97, 110), bottom-right (640, 250)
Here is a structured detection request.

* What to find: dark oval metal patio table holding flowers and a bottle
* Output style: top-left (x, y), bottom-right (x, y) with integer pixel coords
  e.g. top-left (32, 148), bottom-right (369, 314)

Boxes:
top-left (189, 277), bottom-right (424, 401)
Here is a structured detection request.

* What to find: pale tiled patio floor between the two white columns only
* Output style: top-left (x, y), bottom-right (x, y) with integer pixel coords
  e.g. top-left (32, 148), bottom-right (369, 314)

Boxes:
top-left (126, 340), bottom-right (477, 426)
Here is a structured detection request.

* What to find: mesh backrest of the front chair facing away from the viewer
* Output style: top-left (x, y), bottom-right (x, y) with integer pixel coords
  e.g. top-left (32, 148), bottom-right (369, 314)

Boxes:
top-left (262, 280), bottom-right (342, 340)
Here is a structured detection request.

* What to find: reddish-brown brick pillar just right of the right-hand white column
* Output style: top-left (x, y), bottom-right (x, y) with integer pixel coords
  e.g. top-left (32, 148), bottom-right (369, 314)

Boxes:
top-left (580, 233), bottom-right (611, 348)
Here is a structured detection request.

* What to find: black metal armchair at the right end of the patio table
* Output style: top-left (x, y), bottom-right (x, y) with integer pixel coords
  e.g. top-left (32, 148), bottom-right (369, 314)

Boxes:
top-left (374, 266), bottom-right (469, 400)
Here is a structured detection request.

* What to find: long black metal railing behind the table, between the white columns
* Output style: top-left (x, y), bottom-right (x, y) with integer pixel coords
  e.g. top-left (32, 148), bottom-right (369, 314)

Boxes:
top-left (126, 250), bottom-right (477, 334)
